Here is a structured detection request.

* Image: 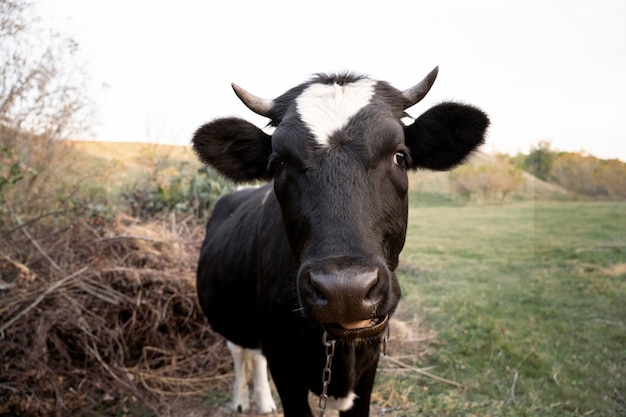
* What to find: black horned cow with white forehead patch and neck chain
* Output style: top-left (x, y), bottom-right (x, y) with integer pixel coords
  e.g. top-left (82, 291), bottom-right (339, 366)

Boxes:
top-left (192, 67), bottom-right (489, 417)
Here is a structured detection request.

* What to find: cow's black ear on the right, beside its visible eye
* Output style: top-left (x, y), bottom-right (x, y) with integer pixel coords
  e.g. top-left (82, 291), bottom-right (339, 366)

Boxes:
top-left (404, 103), bottom-right (489, 171)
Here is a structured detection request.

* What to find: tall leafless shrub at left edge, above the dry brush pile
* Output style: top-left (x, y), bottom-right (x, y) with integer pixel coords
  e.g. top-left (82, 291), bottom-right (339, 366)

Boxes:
top-left (0, 0), bottom-right (92, 230)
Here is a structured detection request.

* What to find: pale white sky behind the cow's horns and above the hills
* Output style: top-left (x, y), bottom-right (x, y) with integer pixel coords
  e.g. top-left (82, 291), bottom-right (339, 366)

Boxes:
top-left (37, 0), bottom-right (626, 161)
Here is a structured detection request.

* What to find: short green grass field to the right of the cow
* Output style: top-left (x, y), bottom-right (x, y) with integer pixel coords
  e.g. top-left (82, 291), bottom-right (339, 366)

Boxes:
top-left (376, 195), bottom-right (626, 416)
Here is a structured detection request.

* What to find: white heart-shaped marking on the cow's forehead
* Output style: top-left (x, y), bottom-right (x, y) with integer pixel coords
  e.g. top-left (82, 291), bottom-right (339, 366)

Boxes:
top-left (296, 79), bottom-right (376, 147)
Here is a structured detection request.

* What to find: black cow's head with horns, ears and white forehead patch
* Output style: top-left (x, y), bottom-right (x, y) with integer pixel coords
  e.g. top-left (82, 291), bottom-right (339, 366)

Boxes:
top-left (193, 68), bottom-right (489, 339)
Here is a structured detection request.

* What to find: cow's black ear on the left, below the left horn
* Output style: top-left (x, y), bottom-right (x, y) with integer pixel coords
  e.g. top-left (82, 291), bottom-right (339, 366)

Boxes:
top-left (191, 117), bottom-right (272, 182)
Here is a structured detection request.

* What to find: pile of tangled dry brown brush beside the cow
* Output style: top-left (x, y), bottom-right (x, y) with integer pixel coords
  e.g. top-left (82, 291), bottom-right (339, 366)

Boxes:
top-left (0, 213), bottom-right (231, 415)
